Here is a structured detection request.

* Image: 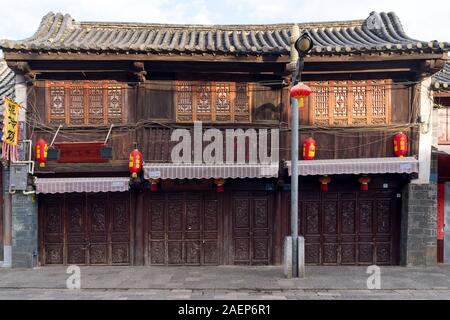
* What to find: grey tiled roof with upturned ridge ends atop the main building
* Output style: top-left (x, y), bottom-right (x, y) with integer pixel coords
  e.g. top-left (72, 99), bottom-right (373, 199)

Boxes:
top-left (0, 12), bottom-right (450, 55)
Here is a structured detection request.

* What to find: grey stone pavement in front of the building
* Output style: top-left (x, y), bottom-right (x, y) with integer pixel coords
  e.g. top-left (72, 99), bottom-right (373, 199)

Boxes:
top-left (0, 266), bottom-right (450, 300)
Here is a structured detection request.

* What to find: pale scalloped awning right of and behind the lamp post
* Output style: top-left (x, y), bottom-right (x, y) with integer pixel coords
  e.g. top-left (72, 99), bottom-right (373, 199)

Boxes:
top-left (286, 157), bottom-right (419, 176)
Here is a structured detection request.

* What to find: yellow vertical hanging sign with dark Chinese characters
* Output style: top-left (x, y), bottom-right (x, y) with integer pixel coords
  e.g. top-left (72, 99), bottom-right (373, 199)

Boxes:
top-left (2, 98), bottom-right (20, 161)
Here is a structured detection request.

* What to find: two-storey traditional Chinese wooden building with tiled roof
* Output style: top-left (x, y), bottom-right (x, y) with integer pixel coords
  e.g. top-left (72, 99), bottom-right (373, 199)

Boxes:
top-left (0, 12), bottom-right (450, 265)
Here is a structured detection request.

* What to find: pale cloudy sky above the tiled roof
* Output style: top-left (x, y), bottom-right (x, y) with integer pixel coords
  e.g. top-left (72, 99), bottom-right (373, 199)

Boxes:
top-left (0, 0), bottom-right (450, 42)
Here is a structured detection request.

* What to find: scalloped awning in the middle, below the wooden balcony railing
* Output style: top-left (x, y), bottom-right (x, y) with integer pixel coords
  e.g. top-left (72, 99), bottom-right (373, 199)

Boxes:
top-left (144, 163), bottom-right (279, 179)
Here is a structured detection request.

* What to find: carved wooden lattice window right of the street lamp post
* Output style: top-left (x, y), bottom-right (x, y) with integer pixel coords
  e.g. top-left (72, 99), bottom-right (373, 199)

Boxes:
top-left (309, 80), bottom-right (391, 126)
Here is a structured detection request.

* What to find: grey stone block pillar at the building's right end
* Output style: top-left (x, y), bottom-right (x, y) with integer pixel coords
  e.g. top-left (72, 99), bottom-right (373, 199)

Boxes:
top-left (400, 183), bottom-right (437, 266)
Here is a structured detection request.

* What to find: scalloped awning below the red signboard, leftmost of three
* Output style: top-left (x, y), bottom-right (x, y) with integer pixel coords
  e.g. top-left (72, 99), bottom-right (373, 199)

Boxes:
top-left (35, 177), bottom-right (130, 193)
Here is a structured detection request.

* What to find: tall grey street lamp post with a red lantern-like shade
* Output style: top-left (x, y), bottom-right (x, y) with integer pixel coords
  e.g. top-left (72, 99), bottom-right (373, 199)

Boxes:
top-left (290, 32), bottom-right (313, 277)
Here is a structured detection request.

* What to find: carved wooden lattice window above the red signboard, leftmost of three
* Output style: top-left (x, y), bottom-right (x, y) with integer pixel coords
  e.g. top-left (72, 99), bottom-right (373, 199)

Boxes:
top-left (46, 81), bottom-right (126, 125)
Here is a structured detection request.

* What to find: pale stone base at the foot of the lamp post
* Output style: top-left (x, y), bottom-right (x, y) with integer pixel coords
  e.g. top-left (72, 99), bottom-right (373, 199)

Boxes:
top-left (283, 236), bottom-right (305, 279)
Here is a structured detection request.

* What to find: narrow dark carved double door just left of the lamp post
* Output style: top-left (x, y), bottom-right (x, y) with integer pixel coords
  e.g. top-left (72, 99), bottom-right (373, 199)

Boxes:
top-left (231, 191), bottom-right (274, 265)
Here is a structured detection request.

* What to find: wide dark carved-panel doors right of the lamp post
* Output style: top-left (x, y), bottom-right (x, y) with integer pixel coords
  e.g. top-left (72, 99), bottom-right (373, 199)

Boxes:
top-left (299, 190), bottom-right (399, 265)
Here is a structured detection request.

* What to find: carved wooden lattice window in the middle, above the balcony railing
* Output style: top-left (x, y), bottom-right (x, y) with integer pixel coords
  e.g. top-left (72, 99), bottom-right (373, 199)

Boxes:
top-left (175, 81), bottom-right (251, 122)
